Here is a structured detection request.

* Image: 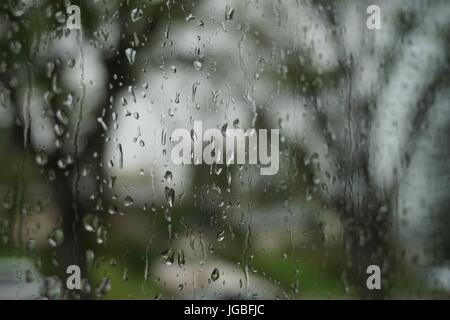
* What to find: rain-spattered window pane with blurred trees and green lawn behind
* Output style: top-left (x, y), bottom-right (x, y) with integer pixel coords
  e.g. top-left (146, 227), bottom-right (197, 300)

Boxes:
top-left (0, 0), bottom-right (450, 299)
